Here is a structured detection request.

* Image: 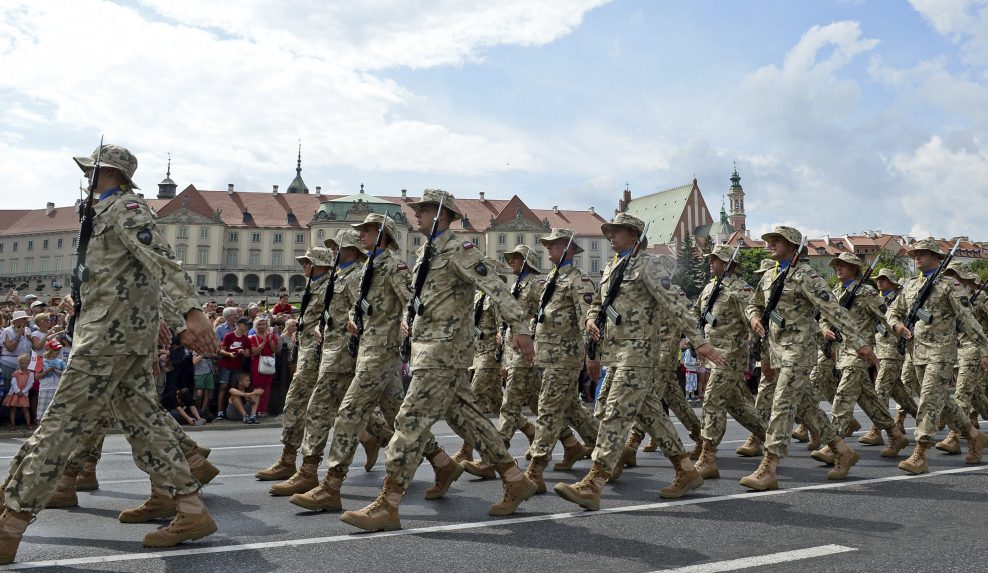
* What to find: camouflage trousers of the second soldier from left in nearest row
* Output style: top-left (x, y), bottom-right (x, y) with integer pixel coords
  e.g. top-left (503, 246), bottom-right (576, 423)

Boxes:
top-left (387, 368), bottom-right (514, 489)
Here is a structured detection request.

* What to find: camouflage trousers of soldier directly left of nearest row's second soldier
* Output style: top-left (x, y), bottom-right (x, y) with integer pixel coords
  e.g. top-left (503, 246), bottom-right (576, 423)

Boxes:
top-left (327, 358), bottom-right (401, 477)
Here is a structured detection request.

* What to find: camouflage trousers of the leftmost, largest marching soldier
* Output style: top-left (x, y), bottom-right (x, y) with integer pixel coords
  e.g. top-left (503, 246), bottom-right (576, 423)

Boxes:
top-left (5, 354), bottom-right (199, 514)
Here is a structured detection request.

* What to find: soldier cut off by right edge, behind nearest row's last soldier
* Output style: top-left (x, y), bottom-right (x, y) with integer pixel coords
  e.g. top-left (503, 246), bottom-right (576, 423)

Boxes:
top-left (936, 261), bottom-right (988, 454)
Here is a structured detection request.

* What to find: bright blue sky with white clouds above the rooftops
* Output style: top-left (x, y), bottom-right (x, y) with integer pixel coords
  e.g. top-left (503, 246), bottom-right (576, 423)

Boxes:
top-left (0, 0), bottom-right (988, 240)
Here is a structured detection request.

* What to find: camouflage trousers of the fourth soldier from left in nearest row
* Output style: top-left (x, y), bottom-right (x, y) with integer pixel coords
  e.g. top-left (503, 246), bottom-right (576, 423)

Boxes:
top-left (765, 366), bottom-right (837, 458)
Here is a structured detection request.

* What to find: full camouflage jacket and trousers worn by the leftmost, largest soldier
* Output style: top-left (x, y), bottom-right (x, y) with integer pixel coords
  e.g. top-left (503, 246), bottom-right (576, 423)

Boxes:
top-left (5, 183), bottom-right (199, 513)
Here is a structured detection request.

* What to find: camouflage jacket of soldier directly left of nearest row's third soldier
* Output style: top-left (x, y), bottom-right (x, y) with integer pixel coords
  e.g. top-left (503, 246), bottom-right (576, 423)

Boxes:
top-left (535, 265), bottom-right (594, 366)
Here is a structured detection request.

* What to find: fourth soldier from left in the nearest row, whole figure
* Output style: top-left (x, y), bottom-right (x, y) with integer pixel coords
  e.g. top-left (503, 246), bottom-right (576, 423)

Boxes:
top-left (741, 226), bottom-right (878, 490)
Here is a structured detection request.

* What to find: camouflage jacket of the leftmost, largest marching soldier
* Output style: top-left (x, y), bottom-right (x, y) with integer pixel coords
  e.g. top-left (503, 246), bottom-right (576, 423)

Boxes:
top-left (72, 191), bottom-right (199, 356)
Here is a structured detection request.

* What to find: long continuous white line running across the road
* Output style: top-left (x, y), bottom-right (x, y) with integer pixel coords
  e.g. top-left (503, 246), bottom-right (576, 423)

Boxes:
top-left (0, 466), bottom-right (988, 571)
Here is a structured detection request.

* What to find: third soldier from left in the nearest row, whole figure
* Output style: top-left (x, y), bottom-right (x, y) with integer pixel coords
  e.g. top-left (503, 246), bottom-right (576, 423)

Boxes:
top-left (552, 213), bottom-right (724, 511)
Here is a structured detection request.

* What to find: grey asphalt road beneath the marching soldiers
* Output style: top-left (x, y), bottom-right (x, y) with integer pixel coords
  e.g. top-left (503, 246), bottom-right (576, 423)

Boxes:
top-left (0, 402), bottom-right (988, 573)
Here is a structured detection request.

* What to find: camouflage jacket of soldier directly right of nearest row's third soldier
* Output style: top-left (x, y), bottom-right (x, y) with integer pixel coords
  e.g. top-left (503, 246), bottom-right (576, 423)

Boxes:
top-left (693, 275), bottom-right (754, 372)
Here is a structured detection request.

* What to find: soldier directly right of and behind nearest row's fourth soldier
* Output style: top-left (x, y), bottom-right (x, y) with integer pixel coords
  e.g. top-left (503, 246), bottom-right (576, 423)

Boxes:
top-left (811, 253), bottom-right (909, 464)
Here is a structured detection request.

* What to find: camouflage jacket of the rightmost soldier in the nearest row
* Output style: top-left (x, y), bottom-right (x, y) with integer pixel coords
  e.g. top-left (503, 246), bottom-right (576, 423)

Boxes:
top-left (886, 270), bottom-right (988, 366)
